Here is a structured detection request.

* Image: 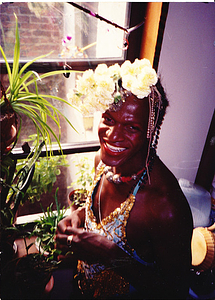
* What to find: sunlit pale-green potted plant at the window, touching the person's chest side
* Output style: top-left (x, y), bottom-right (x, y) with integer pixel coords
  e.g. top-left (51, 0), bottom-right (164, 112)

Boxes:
top-left (68, 155), bottom-right (94, 206)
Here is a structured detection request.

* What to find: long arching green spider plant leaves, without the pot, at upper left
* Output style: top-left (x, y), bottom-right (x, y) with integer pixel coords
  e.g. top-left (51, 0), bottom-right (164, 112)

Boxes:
top-left (0, 15), bottom-right (82, 156)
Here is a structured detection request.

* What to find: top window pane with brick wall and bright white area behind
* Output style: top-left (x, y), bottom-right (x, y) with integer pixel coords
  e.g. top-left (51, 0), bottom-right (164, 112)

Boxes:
top-left (0, 2), bottom-right (128, 62)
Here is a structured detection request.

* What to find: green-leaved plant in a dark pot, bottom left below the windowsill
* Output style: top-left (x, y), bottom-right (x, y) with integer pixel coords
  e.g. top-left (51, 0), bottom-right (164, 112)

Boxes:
top-left (2, 188), bottom-right (69, 299)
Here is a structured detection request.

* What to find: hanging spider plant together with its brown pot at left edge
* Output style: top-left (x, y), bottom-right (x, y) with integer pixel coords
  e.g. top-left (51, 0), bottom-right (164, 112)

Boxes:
top-left (0, 15), bottom-right (80, 230)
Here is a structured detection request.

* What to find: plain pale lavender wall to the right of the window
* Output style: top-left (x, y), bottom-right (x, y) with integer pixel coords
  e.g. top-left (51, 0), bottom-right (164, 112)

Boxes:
top-left (158, 2), bottom-right (215, 182)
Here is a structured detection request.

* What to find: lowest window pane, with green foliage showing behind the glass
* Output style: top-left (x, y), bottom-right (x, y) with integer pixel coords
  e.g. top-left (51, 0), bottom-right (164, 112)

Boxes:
top-left (18, 152), bottom-right (95, 216)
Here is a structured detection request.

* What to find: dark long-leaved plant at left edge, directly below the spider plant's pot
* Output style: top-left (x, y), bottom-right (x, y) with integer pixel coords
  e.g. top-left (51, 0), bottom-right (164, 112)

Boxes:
top-left (0, 142), bottom-right (44, 266)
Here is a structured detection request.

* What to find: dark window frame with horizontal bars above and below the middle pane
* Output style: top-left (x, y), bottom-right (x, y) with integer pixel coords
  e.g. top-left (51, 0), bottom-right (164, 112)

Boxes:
top-left (0, 2), bottom-right (169, 158)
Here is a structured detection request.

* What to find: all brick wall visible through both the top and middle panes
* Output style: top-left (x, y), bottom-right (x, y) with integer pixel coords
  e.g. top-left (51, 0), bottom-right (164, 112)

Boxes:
top-left (0, 2), bottom-right (66, 146)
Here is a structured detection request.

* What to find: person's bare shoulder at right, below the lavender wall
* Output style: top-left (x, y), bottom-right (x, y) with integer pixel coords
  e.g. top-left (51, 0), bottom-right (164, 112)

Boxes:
top-left (139, 158), bottom-right (192, 227)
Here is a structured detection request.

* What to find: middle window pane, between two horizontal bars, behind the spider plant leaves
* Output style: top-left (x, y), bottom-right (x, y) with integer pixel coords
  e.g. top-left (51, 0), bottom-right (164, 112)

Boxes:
top-left (1, 73), bottom-right (101, 147)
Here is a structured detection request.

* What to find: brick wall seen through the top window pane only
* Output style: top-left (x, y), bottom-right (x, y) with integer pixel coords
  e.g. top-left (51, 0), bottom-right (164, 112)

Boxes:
top-left (0, 2), bottom-right (64, 58)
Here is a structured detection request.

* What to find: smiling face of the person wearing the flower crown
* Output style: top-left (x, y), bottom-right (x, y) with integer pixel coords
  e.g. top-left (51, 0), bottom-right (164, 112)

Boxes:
top-left (98, 95), bottom-right (149, 175)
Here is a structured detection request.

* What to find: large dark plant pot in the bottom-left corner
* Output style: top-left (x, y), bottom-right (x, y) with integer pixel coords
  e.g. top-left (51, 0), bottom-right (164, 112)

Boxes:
top-left (1, 253), bottom-right (54, 299)
